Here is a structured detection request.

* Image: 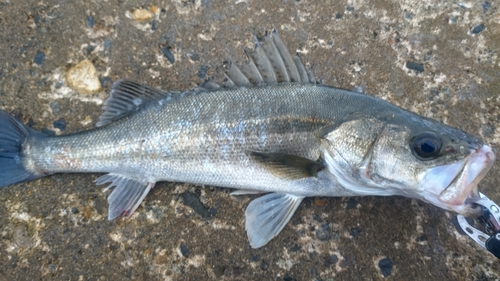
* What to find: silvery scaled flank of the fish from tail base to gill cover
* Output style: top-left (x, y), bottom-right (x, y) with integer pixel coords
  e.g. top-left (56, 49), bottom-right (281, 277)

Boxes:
top-left (24, 84), bottom-right (366, 188)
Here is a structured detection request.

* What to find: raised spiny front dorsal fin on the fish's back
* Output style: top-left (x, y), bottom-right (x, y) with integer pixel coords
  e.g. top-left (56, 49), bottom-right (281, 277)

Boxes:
top-left (226, 30), bottom-right (316, 87)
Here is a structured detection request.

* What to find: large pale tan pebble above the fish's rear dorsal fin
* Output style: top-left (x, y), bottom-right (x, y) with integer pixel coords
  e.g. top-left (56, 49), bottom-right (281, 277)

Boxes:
top-left (66, 59), bottom-right (102, 95)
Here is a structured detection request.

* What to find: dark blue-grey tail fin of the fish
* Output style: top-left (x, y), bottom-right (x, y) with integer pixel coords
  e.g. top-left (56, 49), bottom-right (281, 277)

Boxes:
top-left (0, 110), bottom-right (42, 187)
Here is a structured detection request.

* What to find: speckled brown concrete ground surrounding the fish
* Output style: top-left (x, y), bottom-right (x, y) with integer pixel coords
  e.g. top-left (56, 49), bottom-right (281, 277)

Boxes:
top-left (0, 0), bottom-right (500, 280)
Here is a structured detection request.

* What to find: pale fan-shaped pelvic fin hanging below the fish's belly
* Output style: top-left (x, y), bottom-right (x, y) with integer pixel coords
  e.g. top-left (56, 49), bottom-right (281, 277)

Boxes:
top-left (245, 193), bottom-right (304, 248)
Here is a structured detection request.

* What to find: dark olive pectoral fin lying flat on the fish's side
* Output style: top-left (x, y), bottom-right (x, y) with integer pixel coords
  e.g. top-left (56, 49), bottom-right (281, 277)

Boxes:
top-left (248, 151), bottom-right (324, 180)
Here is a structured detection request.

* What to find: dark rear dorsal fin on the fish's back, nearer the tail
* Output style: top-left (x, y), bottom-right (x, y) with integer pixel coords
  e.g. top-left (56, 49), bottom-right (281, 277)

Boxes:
top-left (96, 80), bottom-right (172, 127)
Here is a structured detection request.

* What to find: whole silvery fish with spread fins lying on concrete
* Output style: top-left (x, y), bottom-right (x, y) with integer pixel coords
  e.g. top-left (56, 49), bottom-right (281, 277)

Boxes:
top-left (0, 30), bottom-right (496, 248)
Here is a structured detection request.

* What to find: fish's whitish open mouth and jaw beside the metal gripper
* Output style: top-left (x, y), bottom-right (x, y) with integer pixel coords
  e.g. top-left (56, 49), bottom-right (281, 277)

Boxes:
top-left (421, 145), bottom-right (496, 216)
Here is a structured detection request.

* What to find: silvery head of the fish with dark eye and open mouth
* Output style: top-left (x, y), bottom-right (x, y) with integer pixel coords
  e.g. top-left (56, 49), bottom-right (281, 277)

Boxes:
top-left (324, 112), bottom-right (495, 215)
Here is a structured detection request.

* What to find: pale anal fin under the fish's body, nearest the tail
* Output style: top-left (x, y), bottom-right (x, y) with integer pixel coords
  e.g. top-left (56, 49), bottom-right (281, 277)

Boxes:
top-left (95, 174), bottom-right (155, 220)
